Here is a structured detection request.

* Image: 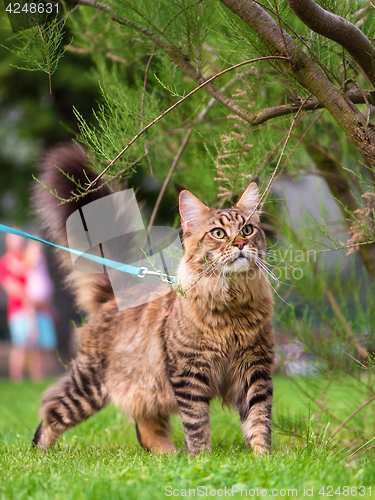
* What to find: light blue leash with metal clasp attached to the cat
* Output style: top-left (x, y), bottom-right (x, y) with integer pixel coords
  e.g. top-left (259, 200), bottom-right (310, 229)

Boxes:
top-left (0, 224), bottom-right (175, 283)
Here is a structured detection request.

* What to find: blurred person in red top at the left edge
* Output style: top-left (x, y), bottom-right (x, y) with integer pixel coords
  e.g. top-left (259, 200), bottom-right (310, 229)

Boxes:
top-left (0, 234), bottom-right (37, 382)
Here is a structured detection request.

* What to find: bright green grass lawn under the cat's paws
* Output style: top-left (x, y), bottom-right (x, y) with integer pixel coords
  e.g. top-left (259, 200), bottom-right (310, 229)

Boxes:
top-left (0, 377), bottom-right (375, 500)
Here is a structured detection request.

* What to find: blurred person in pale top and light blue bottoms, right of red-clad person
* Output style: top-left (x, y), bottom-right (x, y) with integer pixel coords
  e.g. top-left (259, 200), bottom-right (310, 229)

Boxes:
top-left (25, 241), bottom-right (57, 379)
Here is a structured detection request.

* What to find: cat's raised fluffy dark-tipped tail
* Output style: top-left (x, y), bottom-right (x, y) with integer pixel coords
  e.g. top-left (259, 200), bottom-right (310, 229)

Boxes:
top-left (32, 143), bottom-right (114, 314)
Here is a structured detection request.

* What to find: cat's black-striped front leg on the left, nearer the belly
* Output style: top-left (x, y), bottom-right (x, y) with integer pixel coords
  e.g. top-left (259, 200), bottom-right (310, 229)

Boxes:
top-left (169, 367), bottom-right (211, 455)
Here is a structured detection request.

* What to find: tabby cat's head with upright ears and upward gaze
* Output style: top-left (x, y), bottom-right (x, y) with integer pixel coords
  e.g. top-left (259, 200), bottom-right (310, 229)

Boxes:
top-left (180, 182), bottom-right (266, 286)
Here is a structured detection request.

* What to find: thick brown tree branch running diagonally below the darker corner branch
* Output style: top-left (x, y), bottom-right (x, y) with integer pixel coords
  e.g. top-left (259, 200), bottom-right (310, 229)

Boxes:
top-left (220, 0), bottom-right (375, 163)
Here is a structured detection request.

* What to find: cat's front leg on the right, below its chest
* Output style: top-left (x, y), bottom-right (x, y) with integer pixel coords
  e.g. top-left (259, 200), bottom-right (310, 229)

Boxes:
top-left (233, 350), bottom-right (273, 453)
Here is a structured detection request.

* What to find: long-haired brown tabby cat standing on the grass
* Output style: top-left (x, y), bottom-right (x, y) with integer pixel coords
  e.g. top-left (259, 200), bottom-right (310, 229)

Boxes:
top-left (33, 145), bottom-right (274, 455)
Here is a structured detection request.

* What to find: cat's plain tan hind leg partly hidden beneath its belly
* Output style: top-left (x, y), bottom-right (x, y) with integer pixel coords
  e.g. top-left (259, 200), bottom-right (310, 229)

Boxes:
top-left (135, 416), bottom-right (177, 453)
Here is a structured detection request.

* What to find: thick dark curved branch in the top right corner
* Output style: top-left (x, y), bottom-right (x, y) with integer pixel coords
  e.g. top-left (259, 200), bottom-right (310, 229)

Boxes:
top-left (287, 0), bottom-right (375, 86)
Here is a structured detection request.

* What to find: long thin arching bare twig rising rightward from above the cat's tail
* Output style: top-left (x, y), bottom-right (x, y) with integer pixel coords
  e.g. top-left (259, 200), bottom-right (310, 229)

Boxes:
top-left (86, 56), bottom-right (289, 192)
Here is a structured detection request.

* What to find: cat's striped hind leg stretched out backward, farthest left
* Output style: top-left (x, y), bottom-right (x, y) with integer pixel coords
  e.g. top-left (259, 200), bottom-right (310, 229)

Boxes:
top-left (33, 359), bottom-right (108, 450)
